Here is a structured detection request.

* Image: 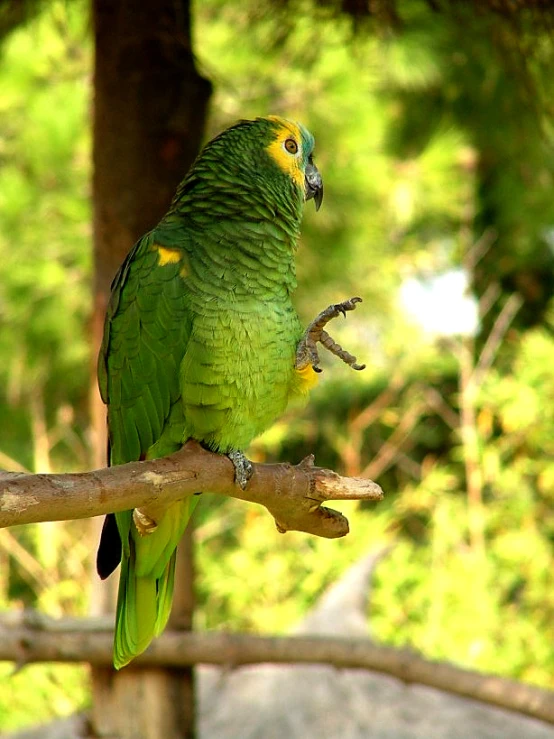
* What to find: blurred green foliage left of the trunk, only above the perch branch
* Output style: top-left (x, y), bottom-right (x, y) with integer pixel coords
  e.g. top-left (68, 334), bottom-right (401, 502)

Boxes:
top-left (0, 2), bottom-right (92, 468)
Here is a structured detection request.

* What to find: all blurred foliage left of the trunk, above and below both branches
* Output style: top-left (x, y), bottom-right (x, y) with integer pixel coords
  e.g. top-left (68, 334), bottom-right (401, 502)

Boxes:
top-left (0, 2), bottom-right (92, 730)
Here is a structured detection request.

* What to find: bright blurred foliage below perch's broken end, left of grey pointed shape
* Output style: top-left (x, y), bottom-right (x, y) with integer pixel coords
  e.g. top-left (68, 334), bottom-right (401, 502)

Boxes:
top-left (196, 494), bottom-right (388, 633)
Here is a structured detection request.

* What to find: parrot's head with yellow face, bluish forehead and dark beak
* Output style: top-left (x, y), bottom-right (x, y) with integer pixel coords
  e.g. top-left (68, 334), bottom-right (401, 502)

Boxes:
top-left (185, 116), bottom-right (323, 210)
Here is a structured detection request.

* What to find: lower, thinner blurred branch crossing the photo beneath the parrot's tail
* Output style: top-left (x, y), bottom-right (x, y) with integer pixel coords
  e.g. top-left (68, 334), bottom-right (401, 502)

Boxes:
top-left (0, 614), bottom-right (554, 724)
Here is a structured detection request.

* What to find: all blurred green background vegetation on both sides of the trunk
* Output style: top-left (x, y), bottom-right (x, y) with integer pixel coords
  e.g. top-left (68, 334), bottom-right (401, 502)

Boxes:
top-left (0, 0), bottom-right (554, 729)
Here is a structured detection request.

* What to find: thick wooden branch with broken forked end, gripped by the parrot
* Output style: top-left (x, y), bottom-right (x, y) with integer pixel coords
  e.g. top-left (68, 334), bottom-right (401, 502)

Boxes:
top-left (0, 441), bottom-right (383, 539)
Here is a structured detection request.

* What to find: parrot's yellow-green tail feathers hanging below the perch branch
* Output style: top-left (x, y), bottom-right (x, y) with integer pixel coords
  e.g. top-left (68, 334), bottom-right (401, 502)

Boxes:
top-left (114, 496), bottom-right (198, 670)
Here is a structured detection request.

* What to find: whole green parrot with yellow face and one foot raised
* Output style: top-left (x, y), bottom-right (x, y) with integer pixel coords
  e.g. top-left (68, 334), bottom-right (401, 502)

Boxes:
top-left (97, 116), bottom-right (361, 669)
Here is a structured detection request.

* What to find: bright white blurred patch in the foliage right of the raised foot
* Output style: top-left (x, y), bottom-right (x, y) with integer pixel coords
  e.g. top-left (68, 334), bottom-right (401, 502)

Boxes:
top-left (400, 269), bottom-right (479, 336)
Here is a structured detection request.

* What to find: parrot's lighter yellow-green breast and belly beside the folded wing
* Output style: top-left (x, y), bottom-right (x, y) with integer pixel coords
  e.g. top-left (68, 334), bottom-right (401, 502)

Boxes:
top-left (181, 301), bottom-right (301, 452)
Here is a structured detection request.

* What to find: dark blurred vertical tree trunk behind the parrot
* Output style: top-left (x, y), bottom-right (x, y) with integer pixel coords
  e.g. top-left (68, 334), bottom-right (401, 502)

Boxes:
top-left (91, 0), bottom-right (211, 739)
